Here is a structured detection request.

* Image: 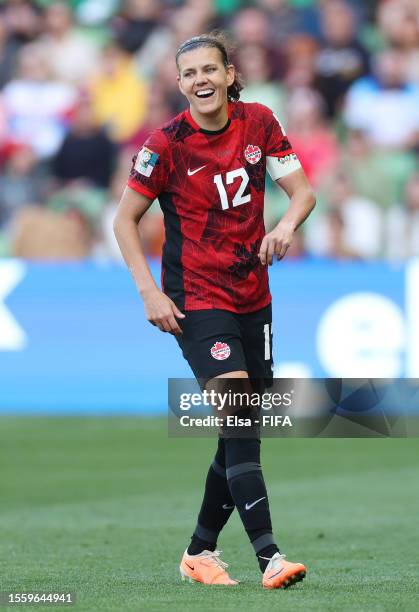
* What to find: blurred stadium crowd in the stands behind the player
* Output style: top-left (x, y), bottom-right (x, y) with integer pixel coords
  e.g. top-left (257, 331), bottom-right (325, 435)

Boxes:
top-left (0, 0), bottom-right (419, 260)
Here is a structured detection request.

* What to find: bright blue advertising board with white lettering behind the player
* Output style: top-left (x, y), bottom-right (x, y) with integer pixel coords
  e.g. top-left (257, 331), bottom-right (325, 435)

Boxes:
top-left (0, 260), bottom-right (419, 414)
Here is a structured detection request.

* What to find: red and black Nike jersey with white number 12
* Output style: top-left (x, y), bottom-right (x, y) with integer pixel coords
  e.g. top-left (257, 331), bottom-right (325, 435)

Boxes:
top-left (128, 102), bottom-right (300, 313)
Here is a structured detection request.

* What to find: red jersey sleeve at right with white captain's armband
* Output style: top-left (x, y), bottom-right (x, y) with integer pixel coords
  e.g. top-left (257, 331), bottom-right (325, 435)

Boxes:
top-left (261, 105), bottom-right (301, 181)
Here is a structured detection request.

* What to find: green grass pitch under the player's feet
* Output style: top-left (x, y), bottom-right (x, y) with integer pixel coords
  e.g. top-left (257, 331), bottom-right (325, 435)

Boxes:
top-left (0, 417), bottom-right (419, 612)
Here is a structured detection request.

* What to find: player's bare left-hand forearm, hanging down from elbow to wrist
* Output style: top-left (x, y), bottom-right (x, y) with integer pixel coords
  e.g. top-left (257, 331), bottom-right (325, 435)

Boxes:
top-left (114, 216), bottom-right (158, 297)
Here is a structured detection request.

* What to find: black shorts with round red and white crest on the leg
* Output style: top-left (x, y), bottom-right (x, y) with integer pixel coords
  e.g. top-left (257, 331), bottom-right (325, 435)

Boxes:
top-left (177, 304), bottom-right (273, 386)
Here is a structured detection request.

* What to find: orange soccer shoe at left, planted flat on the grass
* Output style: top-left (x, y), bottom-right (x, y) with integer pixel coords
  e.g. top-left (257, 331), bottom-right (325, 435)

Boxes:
top-left (179, 550), bottom-right (238, 586)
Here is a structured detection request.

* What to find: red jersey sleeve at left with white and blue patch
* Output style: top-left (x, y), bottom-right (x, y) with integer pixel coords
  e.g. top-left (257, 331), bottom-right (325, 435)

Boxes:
top-left (128, 130), bottom-right (170, 200)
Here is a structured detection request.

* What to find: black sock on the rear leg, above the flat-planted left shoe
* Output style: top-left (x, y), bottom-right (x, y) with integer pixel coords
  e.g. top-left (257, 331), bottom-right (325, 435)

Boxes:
top-left (188, 438), bottom-right (234, 555)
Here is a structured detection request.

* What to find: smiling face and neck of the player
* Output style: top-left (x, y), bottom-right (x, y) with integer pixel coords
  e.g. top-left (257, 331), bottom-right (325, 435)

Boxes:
top-left (178, 47), bottom-right (235, 130)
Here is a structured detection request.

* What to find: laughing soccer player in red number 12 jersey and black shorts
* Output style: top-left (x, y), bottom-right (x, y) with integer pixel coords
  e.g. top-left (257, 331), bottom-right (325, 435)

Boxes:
top-left (114, 35), bottom-right (315, 588)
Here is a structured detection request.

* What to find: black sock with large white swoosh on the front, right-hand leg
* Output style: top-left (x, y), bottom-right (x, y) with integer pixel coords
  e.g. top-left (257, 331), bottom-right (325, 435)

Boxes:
top-left (225, 438), bottom-right (278, 571)
